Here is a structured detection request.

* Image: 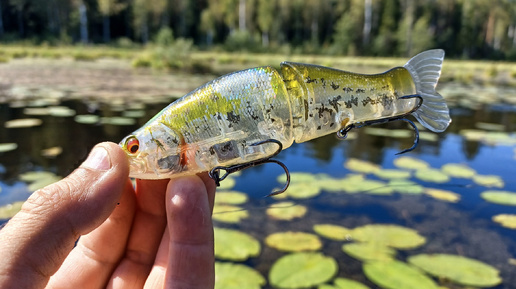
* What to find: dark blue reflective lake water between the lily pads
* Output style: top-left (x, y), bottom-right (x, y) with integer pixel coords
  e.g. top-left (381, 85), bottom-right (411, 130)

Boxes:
top-left (0, 75), bottom-right (516, 289)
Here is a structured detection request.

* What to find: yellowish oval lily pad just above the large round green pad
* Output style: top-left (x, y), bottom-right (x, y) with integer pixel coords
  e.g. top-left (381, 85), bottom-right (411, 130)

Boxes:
top-left (265, 231), bottom-right (322, 252)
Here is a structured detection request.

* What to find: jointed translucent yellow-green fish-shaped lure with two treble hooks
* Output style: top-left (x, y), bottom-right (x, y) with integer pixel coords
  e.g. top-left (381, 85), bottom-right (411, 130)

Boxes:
top-left (120, 50), bottom-right (451, 194)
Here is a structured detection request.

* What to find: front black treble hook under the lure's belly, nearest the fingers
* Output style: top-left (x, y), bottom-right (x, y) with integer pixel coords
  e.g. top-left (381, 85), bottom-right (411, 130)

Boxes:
top-left (208, 139), bottom-right (290, 197)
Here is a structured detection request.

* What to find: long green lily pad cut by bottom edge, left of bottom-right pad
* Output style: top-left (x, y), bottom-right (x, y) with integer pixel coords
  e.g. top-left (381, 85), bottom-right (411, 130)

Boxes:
top-left (363, 260), bottom-right (439, 289)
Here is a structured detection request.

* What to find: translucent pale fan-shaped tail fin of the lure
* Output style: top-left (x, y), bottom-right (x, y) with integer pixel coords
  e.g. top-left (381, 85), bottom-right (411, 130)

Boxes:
top-left (404, 49), bottom-right (451, 132)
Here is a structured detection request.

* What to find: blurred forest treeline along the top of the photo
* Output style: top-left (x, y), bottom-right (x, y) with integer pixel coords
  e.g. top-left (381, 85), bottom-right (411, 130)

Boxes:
top-left (0, 0), bottom-right (516, 60)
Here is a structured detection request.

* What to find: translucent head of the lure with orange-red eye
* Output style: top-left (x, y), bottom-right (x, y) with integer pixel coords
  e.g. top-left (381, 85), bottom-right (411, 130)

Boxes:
top-left (119, 124), bottom-right (184, 179)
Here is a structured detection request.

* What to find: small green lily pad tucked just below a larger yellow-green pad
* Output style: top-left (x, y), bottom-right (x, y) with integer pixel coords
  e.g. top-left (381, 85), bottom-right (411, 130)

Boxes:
top-left (342, 242), bottom-right (396, 261)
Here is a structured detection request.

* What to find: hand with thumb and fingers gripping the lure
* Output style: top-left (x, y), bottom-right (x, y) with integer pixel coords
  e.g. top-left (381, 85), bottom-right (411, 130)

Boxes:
top-left (0, 143), bottom-right (215, 288)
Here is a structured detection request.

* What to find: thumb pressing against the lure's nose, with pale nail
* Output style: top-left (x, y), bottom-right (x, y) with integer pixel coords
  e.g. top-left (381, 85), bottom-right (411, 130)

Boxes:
top-left (0, 143), bottom-right (129, 288)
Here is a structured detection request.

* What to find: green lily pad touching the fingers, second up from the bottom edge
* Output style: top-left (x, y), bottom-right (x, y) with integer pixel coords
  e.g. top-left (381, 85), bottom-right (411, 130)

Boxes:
top-left (213, 227), bottom-right (261, 261)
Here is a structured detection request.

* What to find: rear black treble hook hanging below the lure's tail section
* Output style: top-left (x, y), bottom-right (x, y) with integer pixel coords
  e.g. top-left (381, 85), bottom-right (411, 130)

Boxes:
top-left (337, 94), bottom-right (423, 155)
